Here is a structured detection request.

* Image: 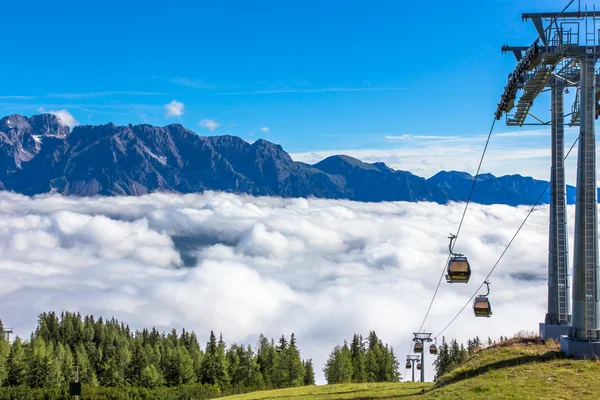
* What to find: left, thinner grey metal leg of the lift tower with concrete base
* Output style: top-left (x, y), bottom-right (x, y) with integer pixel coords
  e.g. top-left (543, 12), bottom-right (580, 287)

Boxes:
top-left (540, 80), bottom-right (571, 341)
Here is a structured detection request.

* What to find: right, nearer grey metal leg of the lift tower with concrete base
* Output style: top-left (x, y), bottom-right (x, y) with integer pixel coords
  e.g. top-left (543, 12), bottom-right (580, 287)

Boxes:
top-left (561, 54), bottom-right (600, 357)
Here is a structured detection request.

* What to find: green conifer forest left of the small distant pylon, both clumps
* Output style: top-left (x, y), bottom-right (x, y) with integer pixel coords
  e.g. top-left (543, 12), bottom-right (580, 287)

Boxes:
top-left (0, 312), bottom-right (400, 400)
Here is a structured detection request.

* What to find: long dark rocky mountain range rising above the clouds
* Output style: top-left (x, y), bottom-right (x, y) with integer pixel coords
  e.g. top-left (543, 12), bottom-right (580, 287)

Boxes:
top-left (0, 114), bottom-right (592, 205)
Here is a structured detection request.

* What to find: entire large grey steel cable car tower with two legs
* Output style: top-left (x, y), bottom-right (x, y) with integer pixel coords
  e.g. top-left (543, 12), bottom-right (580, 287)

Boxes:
top-left (495, 5), bottom-right (600, 357)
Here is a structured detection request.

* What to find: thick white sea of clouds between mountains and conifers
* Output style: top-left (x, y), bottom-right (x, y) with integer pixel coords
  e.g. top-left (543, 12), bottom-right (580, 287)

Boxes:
top-left (0, 192), bottom-right (574, 384)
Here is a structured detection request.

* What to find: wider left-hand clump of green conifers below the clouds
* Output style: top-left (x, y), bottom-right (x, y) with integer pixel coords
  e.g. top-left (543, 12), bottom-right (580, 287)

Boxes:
top-left (0, 312), bottom-right (314, 398)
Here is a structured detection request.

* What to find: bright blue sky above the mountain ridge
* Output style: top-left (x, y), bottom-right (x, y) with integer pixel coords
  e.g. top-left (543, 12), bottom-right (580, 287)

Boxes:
top-left (0, 0), bottom-right (592, 181)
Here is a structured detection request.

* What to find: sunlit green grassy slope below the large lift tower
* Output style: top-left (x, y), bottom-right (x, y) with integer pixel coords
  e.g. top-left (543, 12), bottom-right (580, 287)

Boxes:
top-left (219, 338), bottom-right (600, 400)
